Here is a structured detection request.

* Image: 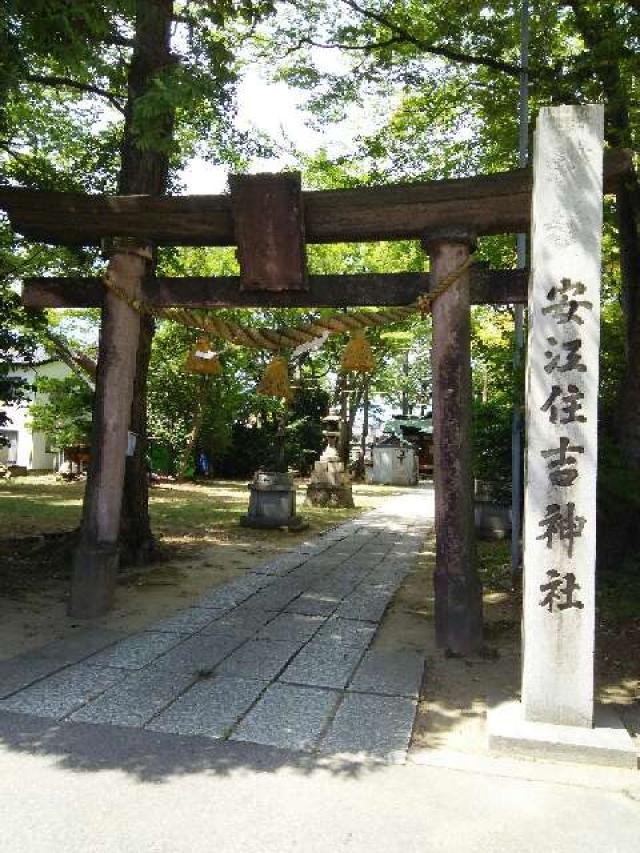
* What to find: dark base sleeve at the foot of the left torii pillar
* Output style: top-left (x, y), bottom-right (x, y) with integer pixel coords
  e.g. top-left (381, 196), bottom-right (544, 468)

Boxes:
top-left (68, 544), bottom-right (120, 619)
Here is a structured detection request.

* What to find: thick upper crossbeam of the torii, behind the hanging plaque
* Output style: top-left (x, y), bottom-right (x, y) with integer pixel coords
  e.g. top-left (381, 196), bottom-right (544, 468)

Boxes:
top-left (0, 150), bottom-right (631, 246)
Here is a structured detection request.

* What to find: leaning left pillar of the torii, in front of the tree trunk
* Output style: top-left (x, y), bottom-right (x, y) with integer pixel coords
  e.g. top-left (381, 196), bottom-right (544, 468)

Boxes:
top-left (69, 239), bottom-right (153, 618)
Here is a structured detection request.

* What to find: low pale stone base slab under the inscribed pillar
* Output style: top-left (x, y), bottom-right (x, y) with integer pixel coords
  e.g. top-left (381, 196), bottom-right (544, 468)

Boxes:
top-left (487, 702), bottom-right (638, 770)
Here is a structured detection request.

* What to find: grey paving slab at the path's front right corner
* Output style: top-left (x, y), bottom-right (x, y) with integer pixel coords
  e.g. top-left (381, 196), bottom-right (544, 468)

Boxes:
top-left (320, 693), bottom-right (417, 762)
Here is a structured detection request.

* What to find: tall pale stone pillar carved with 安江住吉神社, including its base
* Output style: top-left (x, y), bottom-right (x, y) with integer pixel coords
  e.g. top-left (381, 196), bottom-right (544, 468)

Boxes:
top-left (489, 104), bottom-right (637, 767)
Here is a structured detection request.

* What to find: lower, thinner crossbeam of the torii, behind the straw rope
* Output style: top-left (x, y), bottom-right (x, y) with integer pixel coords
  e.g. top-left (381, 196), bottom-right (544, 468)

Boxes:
top-left (22, 264), bottom-right (528, 308)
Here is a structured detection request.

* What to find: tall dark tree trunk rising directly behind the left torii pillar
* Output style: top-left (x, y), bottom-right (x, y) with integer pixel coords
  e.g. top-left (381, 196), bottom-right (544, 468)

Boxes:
top-left (118, 0), bottom-right (174, 565)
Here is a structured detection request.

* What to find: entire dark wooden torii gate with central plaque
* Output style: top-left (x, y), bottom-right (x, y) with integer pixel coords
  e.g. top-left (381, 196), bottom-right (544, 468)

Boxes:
top-left (0, 152), bottom-right (629, 654)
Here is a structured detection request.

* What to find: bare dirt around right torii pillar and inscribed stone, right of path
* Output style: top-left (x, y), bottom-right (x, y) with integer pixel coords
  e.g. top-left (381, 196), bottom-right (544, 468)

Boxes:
top-left (402, 538), bottom-right (640, 755)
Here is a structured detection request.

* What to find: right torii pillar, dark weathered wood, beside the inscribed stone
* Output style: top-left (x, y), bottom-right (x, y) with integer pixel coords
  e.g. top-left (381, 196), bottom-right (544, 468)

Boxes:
top-left (422, 228), bottom-right (483, 655)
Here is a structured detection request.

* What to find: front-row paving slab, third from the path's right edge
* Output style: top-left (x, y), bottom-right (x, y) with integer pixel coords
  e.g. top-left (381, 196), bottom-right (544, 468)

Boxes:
top-left (146, 676), bottom-right (268, 738)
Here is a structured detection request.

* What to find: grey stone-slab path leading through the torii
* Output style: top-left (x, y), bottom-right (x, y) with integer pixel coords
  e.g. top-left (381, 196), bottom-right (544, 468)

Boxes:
top-left (0, 488), bottom-right (433, 761)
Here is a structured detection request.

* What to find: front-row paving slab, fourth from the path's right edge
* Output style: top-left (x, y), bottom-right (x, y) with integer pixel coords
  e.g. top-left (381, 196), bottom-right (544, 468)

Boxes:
top-left (71, 664), bottom-right (195, 728)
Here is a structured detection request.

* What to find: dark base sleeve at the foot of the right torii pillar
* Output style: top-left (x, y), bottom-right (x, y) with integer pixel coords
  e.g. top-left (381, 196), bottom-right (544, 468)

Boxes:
top-left (433, 570), bottom-right (484, 655)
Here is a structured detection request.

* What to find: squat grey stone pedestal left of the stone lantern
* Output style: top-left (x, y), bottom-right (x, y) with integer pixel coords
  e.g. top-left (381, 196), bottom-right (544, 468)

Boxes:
top-left (240, 471), bottom-right (306, 530)
